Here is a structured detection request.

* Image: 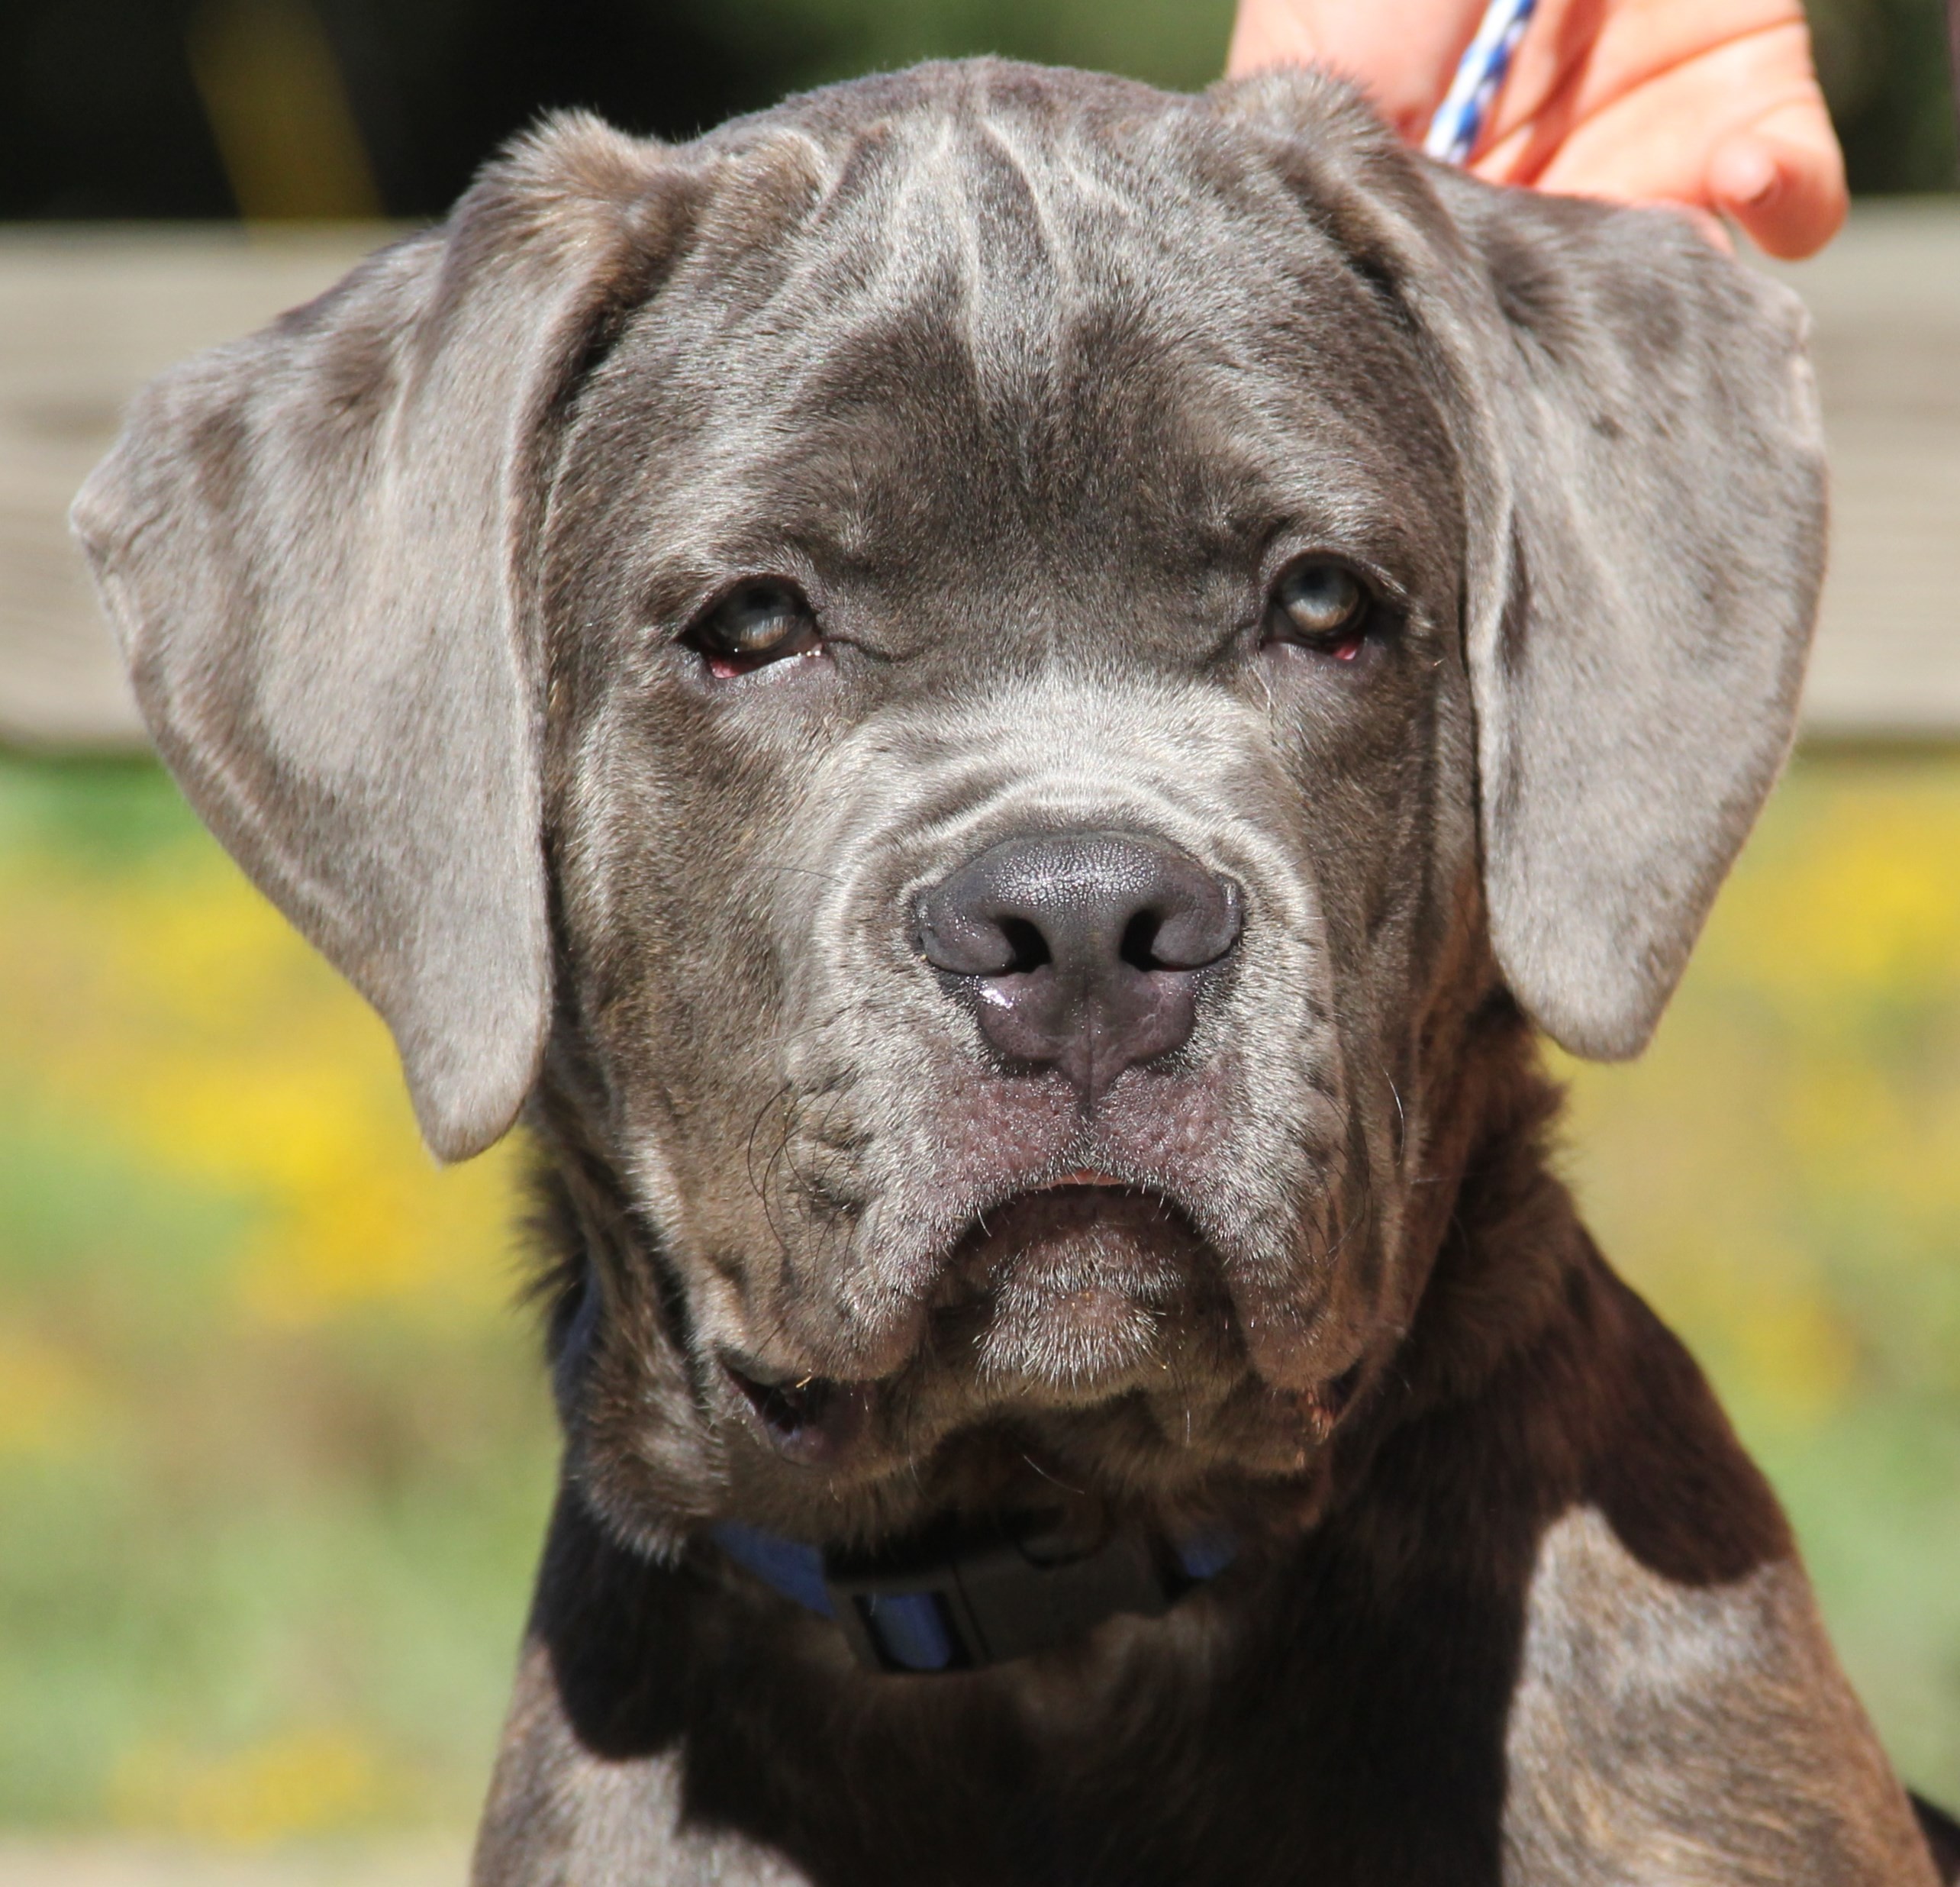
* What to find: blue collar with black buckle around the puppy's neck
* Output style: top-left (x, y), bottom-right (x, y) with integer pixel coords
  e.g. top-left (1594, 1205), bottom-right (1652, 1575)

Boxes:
top-left (714, 1521), bottom-right (1236, 1672)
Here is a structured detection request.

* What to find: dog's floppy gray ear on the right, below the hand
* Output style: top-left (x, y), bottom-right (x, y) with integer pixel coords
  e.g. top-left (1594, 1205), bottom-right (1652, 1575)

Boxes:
top-left (1411, 173), bottom-right (1825, 1060)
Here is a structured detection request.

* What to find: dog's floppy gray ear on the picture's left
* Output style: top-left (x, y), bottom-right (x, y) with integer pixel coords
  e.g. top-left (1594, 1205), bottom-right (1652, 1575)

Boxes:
top-left (73, 115), bottom-right (696, 1160)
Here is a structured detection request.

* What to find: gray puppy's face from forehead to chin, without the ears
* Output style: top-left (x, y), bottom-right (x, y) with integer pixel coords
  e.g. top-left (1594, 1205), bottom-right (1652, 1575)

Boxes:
top-left (545, 95), bottom-right (1474, 1528)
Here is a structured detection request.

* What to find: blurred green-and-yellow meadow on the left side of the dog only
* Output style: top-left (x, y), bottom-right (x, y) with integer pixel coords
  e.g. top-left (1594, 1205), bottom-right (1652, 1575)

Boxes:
top-left (0, 760), bottom-right (553, 1840)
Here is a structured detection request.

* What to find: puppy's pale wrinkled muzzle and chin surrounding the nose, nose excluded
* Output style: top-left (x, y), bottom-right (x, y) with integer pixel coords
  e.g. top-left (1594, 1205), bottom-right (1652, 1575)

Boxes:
top-left (701, 676), bottom-right (1346, 1434)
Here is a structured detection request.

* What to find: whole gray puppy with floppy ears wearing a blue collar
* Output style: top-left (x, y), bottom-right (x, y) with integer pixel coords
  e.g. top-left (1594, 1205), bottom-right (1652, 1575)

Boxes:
top-left (76, 63), bottom-right (1960, 1887)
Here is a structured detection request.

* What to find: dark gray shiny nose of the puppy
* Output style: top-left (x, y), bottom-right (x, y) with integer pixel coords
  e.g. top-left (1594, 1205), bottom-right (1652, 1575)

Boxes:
top-left (917, 833), bottom-right (1243, 1107)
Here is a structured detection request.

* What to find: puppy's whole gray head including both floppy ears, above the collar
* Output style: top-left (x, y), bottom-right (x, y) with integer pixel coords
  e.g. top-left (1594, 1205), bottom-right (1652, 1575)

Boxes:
top-left (79, 65), bottom-right (1819, 1534)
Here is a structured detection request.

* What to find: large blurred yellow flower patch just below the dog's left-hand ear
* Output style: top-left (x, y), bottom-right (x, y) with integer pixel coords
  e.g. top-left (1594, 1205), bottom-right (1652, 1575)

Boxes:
top-left (0, 844), bottom-right (521, 1323)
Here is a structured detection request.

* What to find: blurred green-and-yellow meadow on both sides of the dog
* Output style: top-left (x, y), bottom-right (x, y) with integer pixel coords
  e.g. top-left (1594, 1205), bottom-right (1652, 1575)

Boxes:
top-left (0, 758), bottom-right (1960, 1840)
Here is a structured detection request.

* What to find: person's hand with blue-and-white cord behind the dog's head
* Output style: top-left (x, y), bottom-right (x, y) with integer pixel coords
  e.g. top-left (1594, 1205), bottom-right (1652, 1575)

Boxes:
top-left (1229, 0), bottom-right (1846, 256)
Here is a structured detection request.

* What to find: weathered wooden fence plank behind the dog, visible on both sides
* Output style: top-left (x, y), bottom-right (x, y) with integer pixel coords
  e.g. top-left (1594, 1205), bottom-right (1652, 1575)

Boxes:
top-left (0, 200), bottom-right (1960, 747)
